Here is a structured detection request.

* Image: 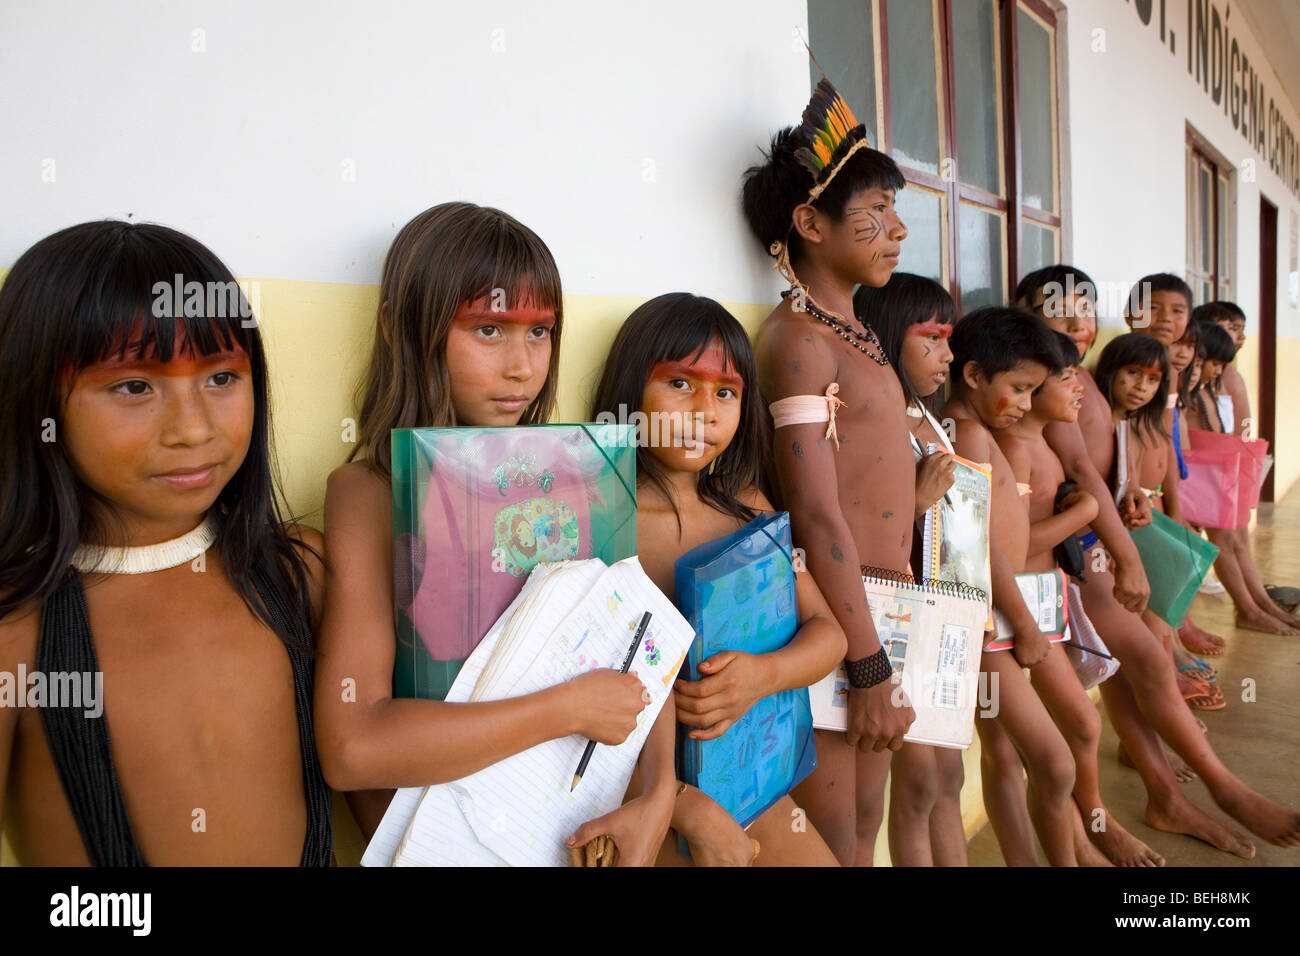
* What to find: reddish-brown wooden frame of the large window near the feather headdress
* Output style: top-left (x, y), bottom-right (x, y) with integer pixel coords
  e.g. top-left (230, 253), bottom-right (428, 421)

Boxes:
top-left (871, 0), bottom-right (1063, 311)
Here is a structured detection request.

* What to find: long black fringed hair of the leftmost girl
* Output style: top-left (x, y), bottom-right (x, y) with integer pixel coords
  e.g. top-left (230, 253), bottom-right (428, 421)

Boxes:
top-left (0, 220), bottom-right (311, 650)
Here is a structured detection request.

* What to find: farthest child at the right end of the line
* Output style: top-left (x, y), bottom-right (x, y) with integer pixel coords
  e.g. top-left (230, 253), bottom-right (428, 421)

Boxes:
top-left (1187, 321), bottom-right (1300, 635)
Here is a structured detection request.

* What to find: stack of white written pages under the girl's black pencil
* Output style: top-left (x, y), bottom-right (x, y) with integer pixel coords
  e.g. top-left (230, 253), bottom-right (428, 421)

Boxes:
top-left (361, 558), bottom-right (694, 866)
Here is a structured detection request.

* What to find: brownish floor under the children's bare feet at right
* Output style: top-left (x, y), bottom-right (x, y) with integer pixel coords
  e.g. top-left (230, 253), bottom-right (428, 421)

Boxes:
top-left (969, 494), bottom-right (1300, 866)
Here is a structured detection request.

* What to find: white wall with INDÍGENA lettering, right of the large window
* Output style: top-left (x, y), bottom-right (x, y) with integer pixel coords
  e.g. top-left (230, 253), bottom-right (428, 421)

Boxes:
top-left (1067, 0), bottom-right (1300, 337)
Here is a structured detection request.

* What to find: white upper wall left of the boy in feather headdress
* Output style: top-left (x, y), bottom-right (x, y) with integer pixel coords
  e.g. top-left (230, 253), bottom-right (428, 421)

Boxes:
top-left (0, 0), bottom-right (809, 302)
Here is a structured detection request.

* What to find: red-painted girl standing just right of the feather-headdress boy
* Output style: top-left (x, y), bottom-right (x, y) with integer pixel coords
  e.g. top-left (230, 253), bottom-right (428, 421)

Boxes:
top-left (853, 272), bottom-right (966, 866)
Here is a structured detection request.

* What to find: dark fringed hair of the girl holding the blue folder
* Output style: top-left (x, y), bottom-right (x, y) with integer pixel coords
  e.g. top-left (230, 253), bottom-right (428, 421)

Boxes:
top-left (590, 293), bottom-right (768, 529)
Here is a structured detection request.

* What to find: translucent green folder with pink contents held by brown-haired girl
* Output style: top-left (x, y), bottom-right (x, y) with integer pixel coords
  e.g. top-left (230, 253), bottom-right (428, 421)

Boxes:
top-left (393, 424), bottom-right (637, 700)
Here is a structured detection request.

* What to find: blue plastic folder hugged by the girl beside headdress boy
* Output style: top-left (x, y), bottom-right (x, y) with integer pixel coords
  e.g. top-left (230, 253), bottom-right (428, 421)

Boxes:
top-left (675, 511), bottom-right (816, 826)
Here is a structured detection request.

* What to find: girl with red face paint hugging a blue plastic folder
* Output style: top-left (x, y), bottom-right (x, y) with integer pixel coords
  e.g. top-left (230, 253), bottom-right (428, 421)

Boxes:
top-left (592, 293), bottom-right (845, 866)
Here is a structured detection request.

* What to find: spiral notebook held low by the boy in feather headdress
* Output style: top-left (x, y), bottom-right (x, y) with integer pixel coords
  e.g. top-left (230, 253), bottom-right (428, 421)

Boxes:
top-left (809, 568), bottom-right (988, 750)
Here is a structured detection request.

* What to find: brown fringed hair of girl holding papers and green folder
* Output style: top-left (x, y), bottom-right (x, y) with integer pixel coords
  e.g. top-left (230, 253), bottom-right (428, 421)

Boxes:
top-left (347, 203), bottom-right (564, 477)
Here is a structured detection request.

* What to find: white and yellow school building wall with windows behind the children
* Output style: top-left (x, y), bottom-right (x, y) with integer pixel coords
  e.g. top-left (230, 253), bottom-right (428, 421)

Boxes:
top-left (0, 0), bottom-right (1300, 857)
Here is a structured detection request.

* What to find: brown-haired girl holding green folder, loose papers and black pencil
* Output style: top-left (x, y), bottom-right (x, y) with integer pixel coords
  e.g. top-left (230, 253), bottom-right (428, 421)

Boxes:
top-left (316, 203), bottom-right (676, 865)
